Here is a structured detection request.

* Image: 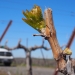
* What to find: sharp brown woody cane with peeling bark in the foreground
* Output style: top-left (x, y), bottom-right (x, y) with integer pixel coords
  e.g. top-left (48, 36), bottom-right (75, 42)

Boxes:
top-left (45, 8), bottom-right (66, 72)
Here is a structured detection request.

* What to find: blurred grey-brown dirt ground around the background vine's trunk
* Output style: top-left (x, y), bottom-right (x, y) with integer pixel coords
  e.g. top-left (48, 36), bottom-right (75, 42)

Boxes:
top-left (0, 66), bottom-right (62, 75)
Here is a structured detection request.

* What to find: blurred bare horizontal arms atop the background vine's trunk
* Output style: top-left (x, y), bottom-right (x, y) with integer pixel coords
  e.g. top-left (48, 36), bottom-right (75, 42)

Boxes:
top-left (0, 39), bottom-right (51, 51)
